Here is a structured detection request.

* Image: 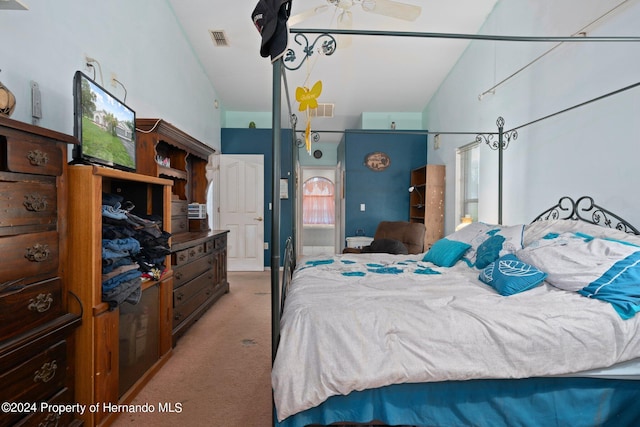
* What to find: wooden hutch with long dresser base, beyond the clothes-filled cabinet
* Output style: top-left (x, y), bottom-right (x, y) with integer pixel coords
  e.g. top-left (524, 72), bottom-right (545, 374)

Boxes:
top-left (136, 118), bottom-right (229, 345)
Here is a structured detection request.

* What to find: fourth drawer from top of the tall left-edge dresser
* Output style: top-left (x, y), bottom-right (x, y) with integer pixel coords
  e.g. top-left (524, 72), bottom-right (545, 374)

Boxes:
top-left (0, 277), bottom-right (62, 341)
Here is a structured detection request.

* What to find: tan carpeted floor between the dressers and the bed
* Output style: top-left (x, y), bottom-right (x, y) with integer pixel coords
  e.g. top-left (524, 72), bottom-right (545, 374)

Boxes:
top-left (112, 271), bottom-right (271, 427)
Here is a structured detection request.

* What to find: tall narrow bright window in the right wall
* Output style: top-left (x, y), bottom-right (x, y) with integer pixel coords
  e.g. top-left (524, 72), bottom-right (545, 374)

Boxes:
top-left (456, 142), bottom-right (480, 223)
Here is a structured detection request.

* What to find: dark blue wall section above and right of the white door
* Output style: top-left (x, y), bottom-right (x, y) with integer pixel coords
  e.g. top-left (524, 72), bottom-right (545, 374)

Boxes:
top-left (221, 128), bottom-right (293, 267)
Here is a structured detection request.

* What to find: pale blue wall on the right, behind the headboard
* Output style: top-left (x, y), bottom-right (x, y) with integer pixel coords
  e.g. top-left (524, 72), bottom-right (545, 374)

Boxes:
top-left (424, 0), bottom-right (640, 232)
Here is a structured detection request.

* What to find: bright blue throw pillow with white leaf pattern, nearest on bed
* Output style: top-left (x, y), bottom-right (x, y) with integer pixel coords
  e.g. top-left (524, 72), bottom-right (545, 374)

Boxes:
top-left (478, 254), bottom-right (547, 296)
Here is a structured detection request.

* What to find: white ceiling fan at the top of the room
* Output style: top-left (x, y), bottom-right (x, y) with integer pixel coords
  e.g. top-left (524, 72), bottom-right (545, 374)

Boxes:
top-left (288, 0), bottom-right (422, 29)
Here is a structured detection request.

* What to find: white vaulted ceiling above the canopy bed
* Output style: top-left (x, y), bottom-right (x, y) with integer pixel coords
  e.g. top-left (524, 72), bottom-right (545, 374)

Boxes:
top-left (169, 0), bottom-right (496, 137)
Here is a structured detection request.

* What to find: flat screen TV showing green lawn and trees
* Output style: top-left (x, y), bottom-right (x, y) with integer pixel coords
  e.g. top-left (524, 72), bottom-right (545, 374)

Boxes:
top-left (72, 71), bottom-right (136, 172)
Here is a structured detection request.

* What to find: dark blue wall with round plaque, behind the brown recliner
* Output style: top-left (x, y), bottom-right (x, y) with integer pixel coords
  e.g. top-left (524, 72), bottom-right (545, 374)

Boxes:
top-left (344, 130), bottom-right (427, 237)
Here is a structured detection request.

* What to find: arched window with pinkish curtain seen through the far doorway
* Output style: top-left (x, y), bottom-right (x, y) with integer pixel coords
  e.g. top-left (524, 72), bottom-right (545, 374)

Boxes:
top-left (302, 176), bottom-right (336, 225)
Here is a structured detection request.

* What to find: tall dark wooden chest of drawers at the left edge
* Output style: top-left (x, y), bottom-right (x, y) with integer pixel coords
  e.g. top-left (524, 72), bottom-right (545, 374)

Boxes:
top-left (0, 117), bottom-right (82, 426)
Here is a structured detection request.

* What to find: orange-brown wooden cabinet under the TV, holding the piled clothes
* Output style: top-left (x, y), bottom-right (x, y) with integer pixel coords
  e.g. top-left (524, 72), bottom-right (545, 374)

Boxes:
top-left (66, 165), bottom-right (173, 426)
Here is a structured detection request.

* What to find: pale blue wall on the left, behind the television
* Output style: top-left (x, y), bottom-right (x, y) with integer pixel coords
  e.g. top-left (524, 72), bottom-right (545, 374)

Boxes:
top-left (0, 0), bottom-right (221, 149)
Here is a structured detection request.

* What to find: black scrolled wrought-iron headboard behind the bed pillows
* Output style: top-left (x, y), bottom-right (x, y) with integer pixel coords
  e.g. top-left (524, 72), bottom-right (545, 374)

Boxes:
top-left (531, 196), bottom-right (640, 235)
